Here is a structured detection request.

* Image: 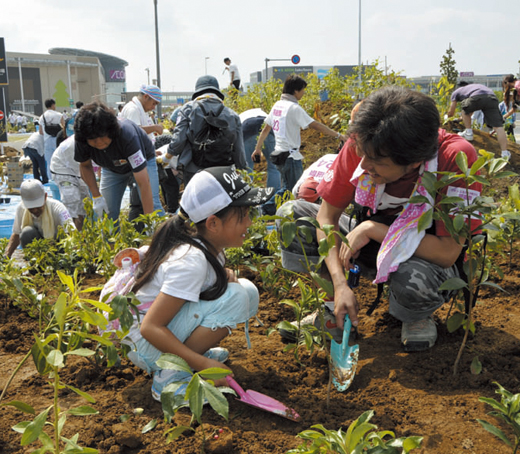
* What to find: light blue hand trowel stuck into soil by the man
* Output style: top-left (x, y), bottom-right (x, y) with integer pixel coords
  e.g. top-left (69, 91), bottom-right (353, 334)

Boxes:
top-left (330, 314), bottom-right (359, 392)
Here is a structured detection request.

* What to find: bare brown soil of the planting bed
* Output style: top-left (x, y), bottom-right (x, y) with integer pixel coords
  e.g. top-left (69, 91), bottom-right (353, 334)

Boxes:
top-left (0, 108), bottom-right (520, 454)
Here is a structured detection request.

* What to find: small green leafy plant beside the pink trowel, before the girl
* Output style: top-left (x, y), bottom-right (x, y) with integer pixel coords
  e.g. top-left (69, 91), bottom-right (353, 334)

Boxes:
top-left (157, 353), bottom-right (236, 453)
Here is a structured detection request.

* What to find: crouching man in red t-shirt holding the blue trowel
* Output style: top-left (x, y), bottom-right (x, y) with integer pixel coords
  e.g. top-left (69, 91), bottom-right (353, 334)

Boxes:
top-left (278, 86), bottom-right (481, 351)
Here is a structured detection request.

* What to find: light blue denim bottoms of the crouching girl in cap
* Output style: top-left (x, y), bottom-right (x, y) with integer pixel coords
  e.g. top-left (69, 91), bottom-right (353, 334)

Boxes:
top-left (123, 279), bottom-right (260, 373)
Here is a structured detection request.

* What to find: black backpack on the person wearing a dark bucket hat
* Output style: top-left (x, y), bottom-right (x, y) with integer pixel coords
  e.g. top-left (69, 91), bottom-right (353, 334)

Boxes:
top-left (187, 102), bottom-right (237, 169)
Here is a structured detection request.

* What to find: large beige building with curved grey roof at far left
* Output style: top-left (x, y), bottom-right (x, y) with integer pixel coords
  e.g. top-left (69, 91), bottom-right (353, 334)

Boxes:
top-left (5, 48), bottom-right (128, 115)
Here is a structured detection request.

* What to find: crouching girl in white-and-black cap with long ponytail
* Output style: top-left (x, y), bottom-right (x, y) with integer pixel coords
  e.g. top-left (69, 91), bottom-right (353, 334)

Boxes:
top-left (124, 167), bottom-right (274, 400)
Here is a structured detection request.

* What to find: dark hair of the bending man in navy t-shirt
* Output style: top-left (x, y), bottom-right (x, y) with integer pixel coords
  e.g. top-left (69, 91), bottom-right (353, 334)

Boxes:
top-left (74, 101), bottom-right (121, 142)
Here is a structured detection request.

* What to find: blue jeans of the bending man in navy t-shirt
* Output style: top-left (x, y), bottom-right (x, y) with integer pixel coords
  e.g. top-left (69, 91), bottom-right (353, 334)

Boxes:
top-left (99, 158), bottom-right (164, 220)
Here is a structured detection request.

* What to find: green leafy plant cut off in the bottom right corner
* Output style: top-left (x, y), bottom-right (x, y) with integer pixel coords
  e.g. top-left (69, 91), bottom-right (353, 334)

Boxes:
top-left (477, 382), bottom-right (520, 454)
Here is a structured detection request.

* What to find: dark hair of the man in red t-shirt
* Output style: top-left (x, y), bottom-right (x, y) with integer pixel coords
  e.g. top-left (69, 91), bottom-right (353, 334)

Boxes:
top-left (348, 86), bottom-right (440, 166)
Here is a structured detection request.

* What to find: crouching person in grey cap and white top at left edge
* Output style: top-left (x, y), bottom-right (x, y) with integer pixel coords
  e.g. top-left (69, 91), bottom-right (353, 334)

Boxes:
top-left (6, 180), bottom-right (75, 257)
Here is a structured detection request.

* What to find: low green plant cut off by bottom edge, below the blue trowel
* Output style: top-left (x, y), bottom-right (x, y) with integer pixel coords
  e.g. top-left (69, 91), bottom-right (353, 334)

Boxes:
top-left (286, 410), bottom-right (422, 454)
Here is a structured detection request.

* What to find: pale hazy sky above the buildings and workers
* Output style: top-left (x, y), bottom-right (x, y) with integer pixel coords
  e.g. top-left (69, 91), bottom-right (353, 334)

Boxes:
top-left (0, 0), bottom-right (520, 91)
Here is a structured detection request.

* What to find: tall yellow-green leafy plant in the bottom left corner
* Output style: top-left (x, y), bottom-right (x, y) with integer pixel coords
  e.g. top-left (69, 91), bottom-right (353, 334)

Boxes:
top-left (2, 271), bottom-right (115, 454)
